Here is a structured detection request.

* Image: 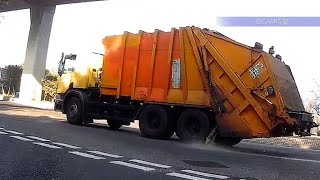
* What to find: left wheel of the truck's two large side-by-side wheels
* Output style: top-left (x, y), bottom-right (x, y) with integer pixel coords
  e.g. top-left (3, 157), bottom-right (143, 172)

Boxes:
top-left (139, 105), bottom-right (174, 139)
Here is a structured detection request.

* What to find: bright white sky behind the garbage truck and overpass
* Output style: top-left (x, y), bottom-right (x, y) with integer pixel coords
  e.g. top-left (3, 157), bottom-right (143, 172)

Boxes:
top-left (0, 0), bottom-right (320, 99)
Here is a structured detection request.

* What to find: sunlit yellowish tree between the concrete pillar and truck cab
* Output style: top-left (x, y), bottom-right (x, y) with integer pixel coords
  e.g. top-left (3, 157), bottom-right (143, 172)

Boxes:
top-left (42, 69), bottom-right (58, 101)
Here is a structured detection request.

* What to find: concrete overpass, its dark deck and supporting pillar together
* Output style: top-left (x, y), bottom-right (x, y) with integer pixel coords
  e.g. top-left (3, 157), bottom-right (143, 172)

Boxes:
top-left (0, 0), bottom-right (101, 101)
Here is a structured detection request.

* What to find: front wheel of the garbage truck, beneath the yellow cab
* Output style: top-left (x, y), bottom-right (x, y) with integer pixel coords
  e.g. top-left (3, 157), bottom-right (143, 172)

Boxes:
top-left (66, 97), bottom-right (82, 125)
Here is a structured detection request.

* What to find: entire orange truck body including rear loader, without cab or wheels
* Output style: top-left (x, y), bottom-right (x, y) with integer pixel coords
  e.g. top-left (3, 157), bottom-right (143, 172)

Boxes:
top-left (101, 27), bottom-right (303, 137)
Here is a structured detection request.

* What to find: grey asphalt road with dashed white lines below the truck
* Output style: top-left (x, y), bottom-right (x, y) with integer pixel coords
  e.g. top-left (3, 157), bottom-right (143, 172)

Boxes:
top-left (0, 102), bottom-right (320, 180)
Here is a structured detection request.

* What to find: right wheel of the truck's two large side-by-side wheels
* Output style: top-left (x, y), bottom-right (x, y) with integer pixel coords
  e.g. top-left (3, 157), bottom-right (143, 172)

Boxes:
top-left (176, 109), bottom-right (210, 143)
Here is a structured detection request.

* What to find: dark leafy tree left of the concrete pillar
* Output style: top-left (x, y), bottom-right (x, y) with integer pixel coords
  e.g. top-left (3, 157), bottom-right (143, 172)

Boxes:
top-left (2, 65), bottom-right (22, 95)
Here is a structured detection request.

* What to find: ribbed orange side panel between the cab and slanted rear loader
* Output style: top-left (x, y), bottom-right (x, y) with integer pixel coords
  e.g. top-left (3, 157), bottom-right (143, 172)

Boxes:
top-left (101, 29), bottom-right (210, 106)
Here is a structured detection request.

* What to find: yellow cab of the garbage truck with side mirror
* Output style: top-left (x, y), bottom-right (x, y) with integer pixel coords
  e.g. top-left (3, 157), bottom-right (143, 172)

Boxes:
top-left (54, 53), bottom-right (102, 111)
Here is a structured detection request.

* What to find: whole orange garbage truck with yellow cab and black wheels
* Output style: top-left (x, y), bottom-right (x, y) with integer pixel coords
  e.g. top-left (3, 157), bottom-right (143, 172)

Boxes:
top-left (55, 26), bottom-right (316, 145)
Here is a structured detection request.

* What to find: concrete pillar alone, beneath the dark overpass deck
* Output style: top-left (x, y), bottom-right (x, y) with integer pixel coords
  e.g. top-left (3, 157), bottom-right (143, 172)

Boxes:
top-left (19, 6), bottom-right (56, 101)
